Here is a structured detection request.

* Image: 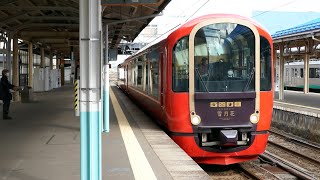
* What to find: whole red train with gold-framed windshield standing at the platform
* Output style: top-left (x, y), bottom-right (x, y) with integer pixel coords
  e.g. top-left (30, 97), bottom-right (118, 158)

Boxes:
top-left (118, 14), bottom-right (273, 165)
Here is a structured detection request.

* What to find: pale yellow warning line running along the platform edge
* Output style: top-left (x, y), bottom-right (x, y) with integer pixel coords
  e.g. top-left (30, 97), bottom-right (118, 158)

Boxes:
top-left (110, 89), bottom-right (157, 180)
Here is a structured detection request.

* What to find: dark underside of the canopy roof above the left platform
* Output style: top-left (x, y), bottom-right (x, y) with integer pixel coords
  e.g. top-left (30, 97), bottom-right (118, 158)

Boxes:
top-left (0, 0), bottom-right (170, 57)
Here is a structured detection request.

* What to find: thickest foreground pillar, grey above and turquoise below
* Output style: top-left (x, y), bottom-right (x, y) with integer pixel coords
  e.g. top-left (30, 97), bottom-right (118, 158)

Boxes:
top-left (79, 0), bottom-right (102, 180)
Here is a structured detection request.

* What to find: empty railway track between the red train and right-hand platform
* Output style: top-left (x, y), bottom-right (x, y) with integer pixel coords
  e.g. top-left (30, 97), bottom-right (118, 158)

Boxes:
top-left (260, 129), bottom-right (320, 179)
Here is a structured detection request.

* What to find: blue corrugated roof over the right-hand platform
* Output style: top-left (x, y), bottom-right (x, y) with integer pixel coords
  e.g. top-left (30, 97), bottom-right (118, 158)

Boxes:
top-left (272, 18), bottom-right (320, 38)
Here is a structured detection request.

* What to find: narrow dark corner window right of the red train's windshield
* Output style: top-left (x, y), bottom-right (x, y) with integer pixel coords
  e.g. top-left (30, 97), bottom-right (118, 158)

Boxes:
top-left (260, 36), bottom-right (272, 91)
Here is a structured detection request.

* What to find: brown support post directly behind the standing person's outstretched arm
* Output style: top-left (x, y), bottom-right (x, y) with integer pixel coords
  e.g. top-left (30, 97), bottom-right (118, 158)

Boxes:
top-left (12, 37), bottom-right (20, 101)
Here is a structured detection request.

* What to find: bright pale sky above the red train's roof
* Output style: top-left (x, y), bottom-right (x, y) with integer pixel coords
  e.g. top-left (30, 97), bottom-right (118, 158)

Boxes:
top-left (135, 0), bottom-right (320, 42)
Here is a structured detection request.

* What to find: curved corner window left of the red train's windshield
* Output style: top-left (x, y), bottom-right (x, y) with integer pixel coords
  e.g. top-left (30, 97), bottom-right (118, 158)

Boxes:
top-left (172, 36), bottom-right (189, 92)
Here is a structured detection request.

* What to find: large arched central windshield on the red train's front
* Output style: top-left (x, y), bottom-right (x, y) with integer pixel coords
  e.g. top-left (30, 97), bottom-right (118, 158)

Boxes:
top-left (194, 23), bottom-right (255, 92)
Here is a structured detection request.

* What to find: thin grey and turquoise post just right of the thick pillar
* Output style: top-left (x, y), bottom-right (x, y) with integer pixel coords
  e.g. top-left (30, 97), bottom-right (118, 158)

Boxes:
top-left (103, 25), bottom-right (110, 132)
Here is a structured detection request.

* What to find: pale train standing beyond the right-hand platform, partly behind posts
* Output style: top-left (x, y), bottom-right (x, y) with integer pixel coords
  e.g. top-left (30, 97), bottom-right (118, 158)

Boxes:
top-left (284, 60), bottom-right (320, 90)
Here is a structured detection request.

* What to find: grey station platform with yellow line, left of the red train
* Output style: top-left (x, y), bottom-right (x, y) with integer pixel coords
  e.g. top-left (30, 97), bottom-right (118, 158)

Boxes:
top-left (0, 86), bottom-right (210, 180)
